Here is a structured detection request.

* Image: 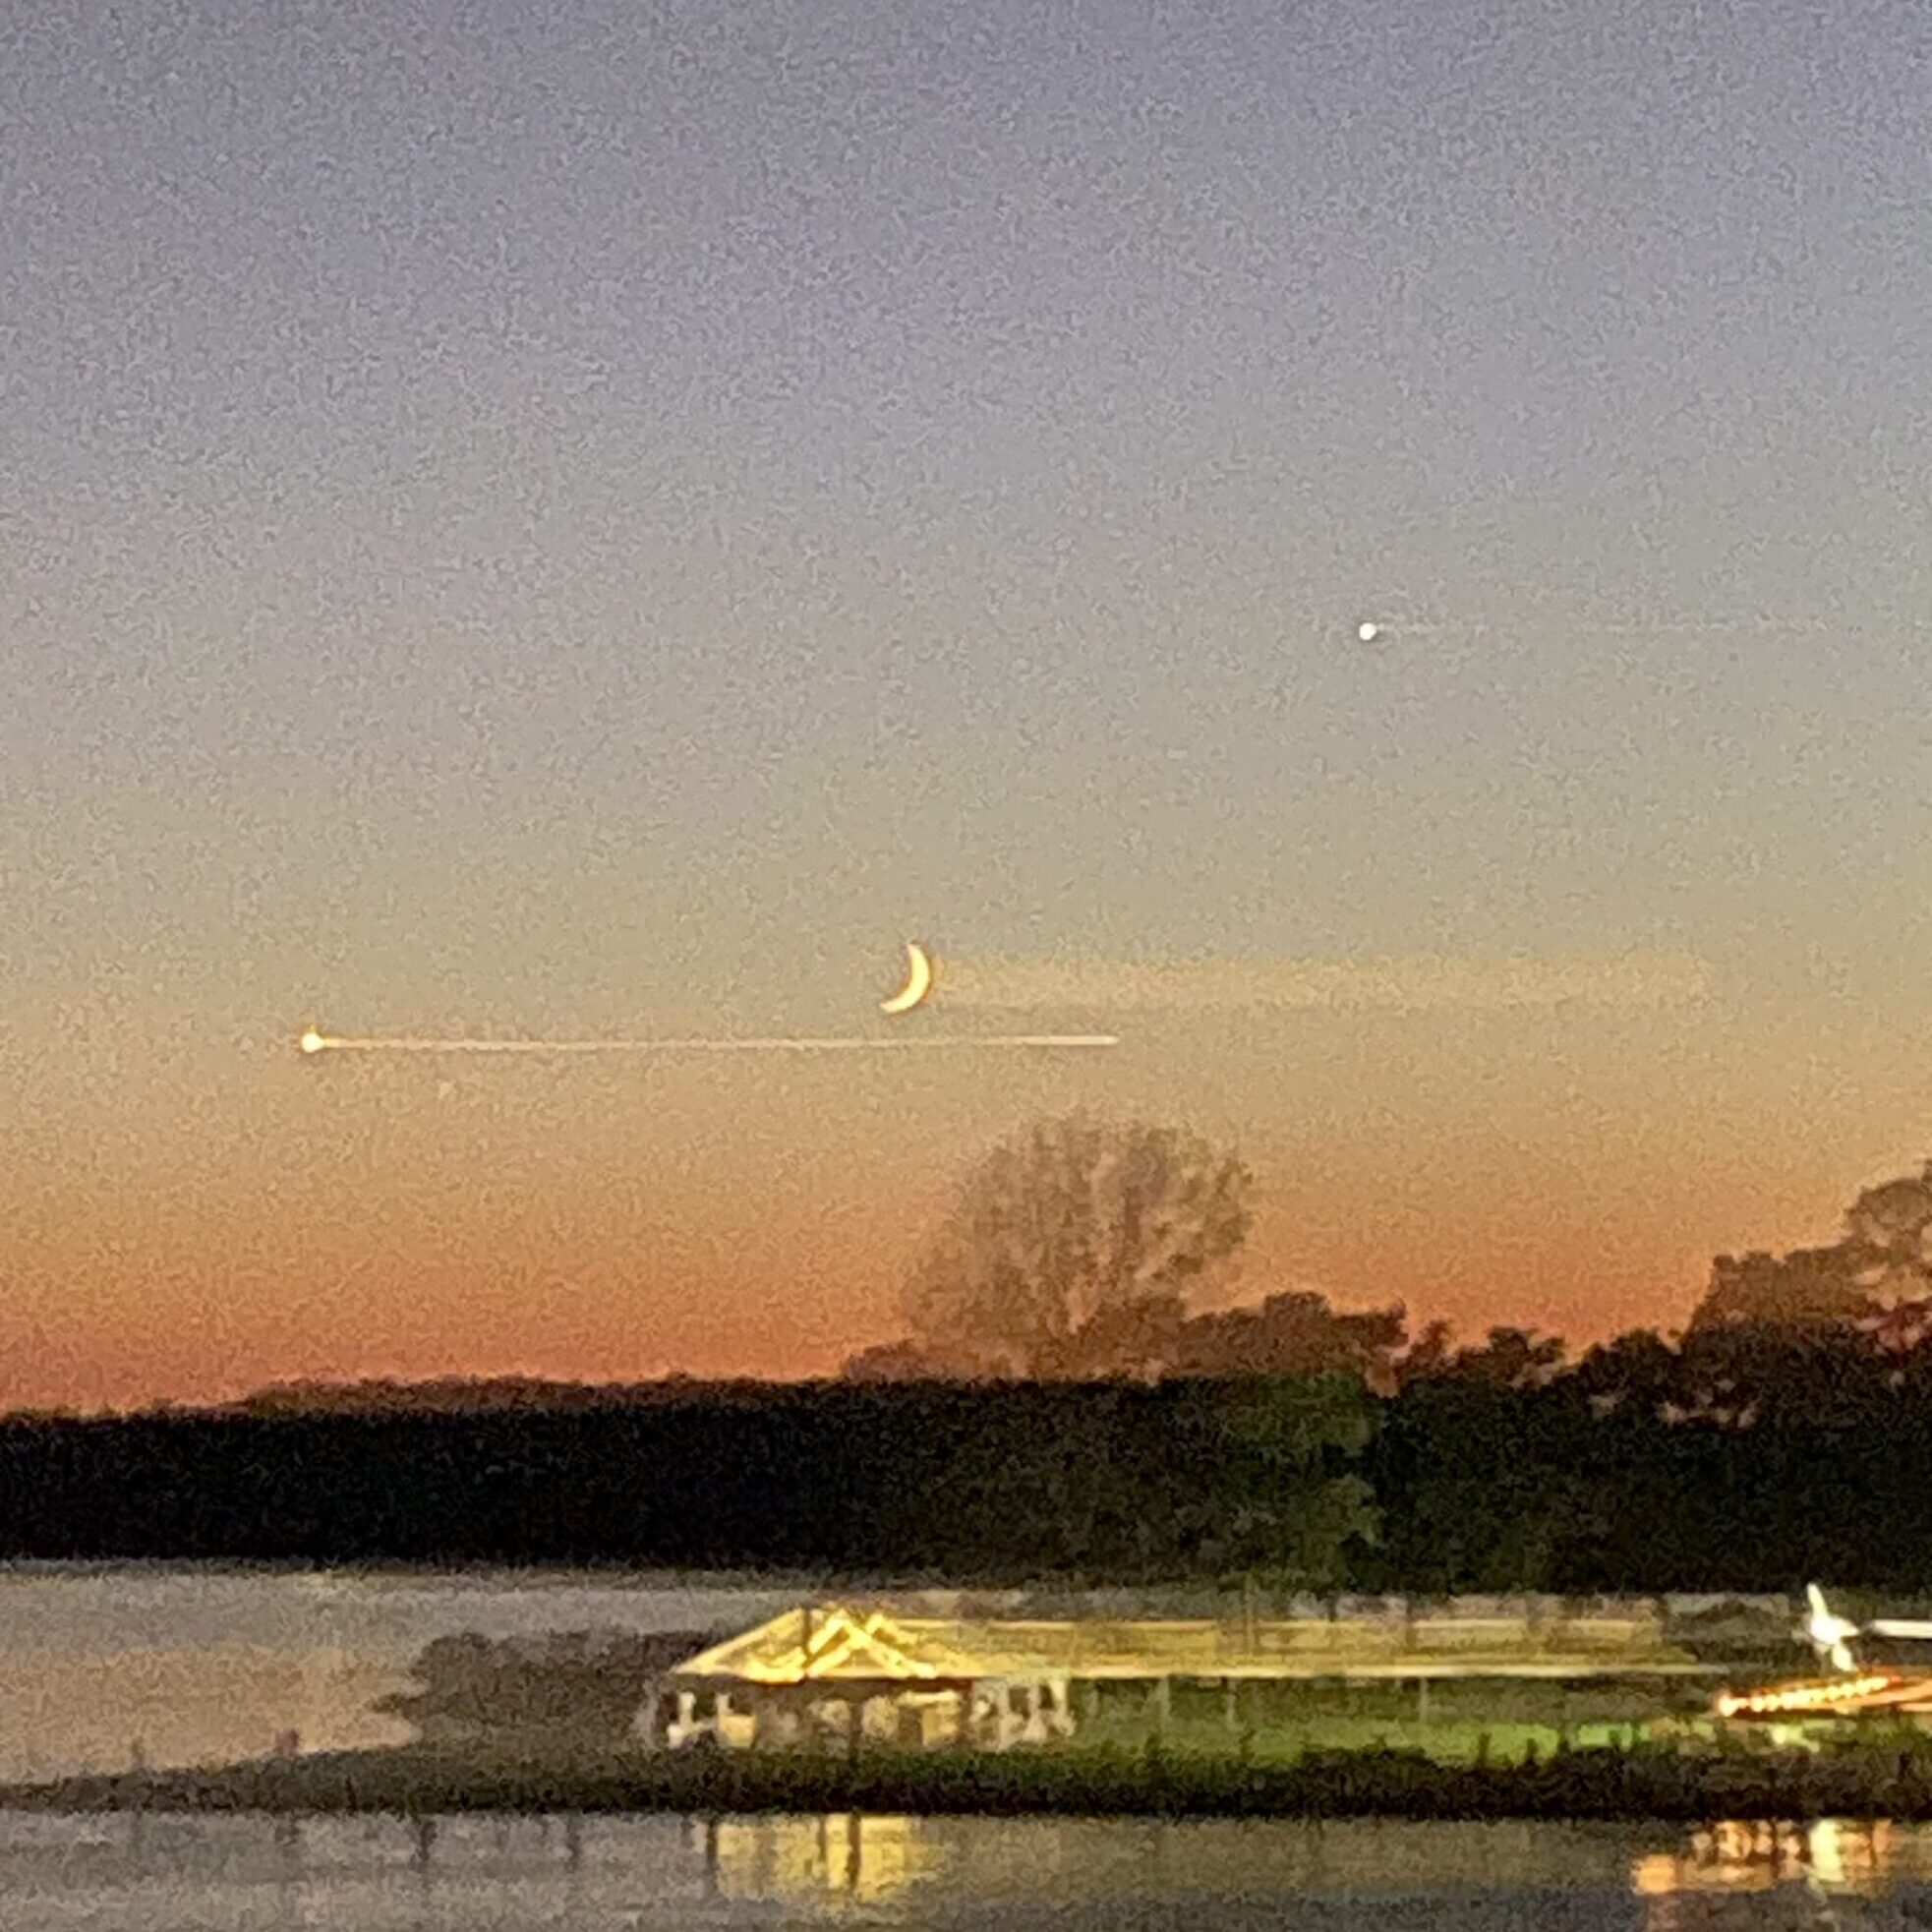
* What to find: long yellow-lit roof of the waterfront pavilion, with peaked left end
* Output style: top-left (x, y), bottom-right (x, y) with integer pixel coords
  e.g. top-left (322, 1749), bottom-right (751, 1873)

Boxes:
top-left (671, 1604), bottom-right (1714, 1684)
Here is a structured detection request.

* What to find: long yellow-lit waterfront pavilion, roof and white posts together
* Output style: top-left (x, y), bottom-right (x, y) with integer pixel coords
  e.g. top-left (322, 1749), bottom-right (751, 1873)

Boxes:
top-left (641, 1604), bottom-right (1722, 1750)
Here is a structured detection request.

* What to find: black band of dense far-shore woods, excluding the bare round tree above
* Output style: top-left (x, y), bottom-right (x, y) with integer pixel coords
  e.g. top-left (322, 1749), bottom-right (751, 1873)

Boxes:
top-left (11, 1319), bottom-right (1932, 1596)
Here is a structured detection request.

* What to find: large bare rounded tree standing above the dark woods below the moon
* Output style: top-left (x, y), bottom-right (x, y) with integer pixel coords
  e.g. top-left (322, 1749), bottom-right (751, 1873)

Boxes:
top-left (907, 1113), bottom-right (1250, 1377)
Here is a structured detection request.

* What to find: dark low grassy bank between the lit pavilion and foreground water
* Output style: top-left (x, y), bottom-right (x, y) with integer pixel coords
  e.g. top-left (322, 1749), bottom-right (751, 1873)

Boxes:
top-left (11, 1742), bottom-right (1932, 1824)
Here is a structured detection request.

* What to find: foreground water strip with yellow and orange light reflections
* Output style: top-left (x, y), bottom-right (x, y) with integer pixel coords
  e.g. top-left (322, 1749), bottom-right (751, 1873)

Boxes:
top-left (0, 1816), bottom-right (1932, 1932)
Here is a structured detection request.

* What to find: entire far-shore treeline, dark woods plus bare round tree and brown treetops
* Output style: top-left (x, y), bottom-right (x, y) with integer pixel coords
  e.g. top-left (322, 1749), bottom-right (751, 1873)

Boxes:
top-left (0, 1117), bottom-right (1932, 1596)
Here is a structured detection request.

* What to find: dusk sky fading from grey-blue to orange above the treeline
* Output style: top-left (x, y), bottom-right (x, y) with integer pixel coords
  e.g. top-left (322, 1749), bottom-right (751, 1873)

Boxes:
top-left (0, 0), bottom-right (1932, 1405)
